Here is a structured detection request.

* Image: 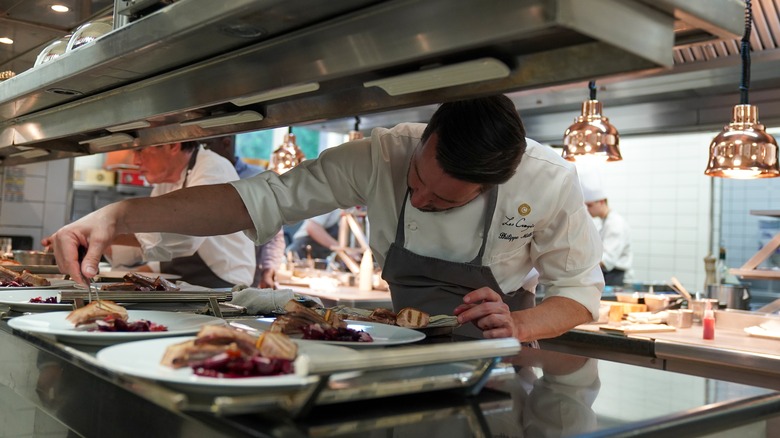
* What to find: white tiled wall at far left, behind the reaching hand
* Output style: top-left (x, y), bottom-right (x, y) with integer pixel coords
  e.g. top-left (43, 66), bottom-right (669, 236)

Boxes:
top-left (0, 160), bottom-right (73, 249)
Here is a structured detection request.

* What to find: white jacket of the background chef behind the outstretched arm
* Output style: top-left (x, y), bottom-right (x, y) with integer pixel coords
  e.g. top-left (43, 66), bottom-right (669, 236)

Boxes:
top-left (135, 147), bottom-right (254, 285)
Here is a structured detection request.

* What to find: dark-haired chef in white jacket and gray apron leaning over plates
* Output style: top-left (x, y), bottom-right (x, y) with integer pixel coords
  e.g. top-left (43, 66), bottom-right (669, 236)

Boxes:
top-left (49, 95), bottom-right (604, 341)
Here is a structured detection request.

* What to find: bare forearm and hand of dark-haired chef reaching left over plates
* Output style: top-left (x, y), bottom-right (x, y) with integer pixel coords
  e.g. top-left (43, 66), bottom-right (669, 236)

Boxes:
top-left (42, 184), bottom-right (253, 279)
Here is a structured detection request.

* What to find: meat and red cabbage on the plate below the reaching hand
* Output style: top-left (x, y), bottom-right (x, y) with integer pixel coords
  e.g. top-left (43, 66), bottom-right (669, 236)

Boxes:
top-left (65, 300), bottom-right (168, 332)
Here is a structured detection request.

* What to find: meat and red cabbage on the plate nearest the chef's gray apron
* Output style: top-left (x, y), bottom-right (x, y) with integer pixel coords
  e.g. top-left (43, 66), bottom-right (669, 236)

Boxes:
top-left (271, 300), bottom-right (374, 342)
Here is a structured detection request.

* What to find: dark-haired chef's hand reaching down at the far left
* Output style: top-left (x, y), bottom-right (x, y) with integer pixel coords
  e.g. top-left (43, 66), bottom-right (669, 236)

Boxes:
top-left (41, 208), bottom-right (116, 286)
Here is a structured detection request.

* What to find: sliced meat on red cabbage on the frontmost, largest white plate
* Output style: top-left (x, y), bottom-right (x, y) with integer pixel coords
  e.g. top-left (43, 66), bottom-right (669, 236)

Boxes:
top-left (160, 325), bottom-right (298, 378)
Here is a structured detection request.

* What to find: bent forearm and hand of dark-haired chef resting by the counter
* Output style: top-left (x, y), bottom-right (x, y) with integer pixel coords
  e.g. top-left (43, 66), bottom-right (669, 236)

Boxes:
top-left (454, 287), bottom-right (593, 342)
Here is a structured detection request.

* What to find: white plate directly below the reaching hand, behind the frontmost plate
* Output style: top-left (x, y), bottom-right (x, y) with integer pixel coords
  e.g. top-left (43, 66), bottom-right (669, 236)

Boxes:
top-left (8, 310), bottom-right (225, 345)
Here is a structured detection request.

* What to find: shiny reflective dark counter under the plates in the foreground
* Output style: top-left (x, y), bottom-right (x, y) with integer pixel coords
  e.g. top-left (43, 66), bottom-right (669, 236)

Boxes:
top-left (0, 314), bottom-right (780, 438)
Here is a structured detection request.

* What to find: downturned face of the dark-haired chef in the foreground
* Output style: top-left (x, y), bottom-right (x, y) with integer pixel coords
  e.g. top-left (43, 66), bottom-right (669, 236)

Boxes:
top-left (406, 134), bottom-right (482, 212)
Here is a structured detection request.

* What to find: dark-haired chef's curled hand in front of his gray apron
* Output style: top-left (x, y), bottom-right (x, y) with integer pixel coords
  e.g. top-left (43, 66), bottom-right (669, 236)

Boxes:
top-left (454, 287), bottom-right (515, 339)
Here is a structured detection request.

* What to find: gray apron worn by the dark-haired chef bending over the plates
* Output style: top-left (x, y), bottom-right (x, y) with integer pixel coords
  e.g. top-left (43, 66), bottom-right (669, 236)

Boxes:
top-left (382, 188), bottom-right (535, 338)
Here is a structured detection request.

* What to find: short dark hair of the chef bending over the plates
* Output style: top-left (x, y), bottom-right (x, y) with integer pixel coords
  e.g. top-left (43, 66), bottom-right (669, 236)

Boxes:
top-left (422, 94), bottom-right (526, 187)
